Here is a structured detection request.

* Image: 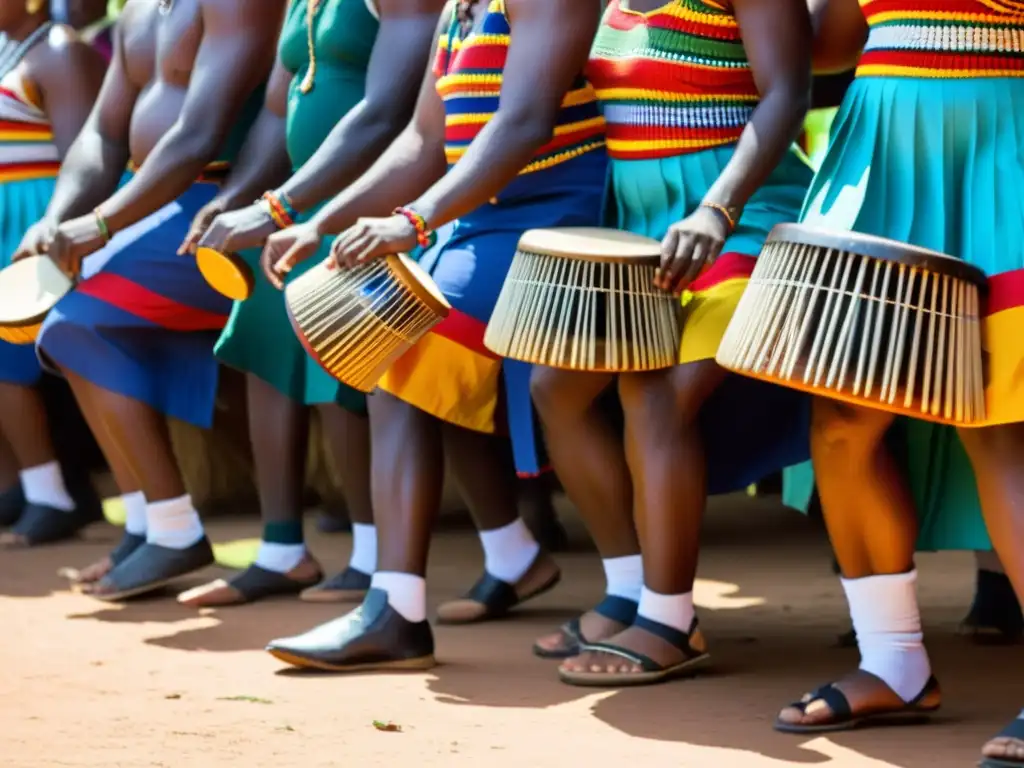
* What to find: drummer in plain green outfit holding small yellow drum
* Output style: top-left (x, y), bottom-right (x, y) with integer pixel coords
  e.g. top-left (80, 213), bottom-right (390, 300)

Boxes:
top-left (169, 0), bottom-right (444, 606)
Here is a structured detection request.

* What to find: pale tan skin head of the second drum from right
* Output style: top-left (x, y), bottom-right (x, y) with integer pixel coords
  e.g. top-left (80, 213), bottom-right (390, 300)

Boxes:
top-left (518, 226), bottom-right (662, 262)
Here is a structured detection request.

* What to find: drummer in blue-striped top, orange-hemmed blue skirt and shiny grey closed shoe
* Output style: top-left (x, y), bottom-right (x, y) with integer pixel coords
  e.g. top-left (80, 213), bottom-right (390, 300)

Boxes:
top-left (256, 0), bottom-right (606, 671)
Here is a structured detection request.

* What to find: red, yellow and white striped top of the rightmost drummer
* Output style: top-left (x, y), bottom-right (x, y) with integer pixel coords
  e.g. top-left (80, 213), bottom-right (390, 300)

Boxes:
top-left (857, 0), bottom-right (1024, 78)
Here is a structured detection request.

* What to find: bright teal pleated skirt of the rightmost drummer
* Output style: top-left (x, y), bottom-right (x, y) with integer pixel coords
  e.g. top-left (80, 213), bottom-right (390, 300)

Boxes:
top-left (783, 78), bottom-right (1024, 551)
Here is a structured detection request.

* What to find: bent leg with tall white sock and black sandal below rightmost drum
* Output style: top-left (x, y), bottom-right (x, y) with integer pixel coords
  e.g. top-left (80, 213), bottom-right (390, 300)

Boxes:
top-left (775, 398), bottom-right (941, 733)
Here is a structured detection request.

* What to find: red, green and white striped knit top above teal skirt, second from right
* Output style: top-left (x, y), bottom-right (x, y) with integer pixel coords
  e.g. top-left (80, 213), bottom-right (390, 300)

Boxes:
top-left (587, 0), bottom-right (759, 160)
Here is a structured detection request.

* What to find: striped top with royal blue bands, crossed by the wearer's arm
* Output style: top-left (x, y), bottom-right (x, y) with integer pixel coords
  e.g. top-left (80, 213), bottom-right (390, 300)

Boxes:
top-left (434, 0), bottom-right (604, 174)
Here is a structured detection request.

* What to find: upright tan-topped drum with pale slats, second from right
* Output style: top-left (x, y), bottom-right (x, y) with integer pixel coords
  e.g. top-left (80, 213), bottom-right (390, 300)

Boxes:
top-left (483, 227), bottom-right (682, 373)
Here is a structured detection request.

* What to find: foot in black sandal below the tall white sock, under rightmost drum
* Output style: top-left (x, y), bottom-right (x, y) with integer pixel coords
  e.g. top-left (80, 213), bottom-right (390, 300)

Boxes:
top-left (776, 670), bottom-right (942, 728)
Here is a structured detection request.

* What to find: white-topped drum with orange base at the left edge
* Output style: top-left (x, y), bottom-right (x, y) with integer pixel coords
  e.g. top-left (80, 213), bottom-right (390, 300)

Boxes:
top-left (0, 256), bottom-right (74, 344)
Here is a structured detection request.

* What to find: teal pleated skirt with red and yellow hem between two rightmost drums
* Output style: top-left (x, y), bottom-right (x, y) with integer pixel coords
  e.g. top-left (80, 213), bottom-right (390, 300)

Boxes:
top-left (610, 146), bottom-right (812, 494)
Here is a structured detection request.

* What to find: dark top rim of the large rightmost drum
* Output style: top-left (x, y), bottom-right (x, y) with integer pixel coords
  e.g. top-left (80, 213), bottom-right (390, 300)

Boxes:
top-left (765, 228), bottom-right (988, 290)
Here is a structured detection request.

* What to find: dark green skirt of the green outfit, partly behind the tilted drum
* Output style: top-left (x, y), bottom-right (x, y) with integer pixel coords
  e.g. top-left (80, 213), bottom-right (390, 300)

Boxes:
top-left (209, 204), bottom-right (367, 413)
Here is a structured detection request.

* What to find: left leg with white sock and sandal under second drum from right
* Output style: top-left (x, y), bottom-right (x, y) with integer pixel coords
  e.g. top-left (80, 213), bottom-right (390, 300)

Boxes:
top-left (530, 367), bottom-right (643, 658)
